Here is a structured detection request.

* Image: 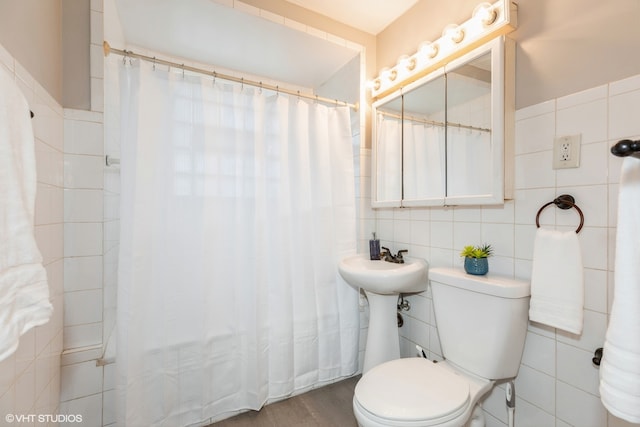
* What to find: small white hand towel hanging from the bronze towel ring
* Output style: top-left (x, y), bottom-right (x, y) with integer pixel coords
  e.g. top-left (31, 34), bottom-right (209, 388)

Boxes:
top-left (529, 228), bottom-right (584, 334)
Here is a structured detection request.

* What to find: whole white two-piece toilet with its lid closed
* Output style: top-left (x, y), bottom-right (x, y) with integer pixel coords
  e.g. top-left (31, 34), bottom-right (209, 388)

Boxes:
top-left (353, 268), bottom-right (530, 427)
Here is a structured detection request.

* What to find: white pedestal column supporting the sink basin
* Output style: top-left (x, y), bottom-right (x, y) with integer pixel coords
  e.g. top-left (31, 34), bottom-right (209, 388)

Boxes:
top-left (362, 291), bottom-right (400, 374)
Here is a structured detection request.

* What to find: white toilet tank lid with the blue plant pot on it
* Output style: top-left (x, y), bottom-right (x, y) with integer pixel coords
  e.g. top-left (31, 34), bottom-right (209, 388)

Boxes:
top-left (429, 267), bottom-right (531, 298)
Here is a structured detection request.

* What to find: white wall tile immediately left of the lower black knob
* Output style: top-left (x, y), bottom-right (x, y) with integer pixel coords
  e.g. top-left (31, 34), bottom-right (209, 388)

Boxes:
top-left (557, 343), bottom-right (600, 396)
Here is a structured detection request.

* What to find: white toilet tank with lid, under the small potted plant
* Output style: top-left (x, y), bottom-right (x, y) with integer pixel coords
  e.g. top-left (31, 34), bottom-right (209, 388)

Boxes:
top-left (429, 268), bottom-right (531, 380)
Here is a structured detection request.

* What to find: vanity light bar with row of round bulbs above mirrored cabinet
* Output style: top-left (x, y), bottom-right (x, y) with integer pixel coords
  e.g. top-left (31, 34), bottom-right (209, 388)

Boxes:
top-left (368, 0), bottom-right (518, 100)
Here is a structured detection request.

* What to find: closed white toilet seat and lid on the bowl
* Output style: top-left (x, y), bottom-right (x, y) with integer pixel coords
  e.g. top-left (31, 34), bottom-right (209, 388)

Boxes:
top-left (354, 357), bottom-right (471, 426)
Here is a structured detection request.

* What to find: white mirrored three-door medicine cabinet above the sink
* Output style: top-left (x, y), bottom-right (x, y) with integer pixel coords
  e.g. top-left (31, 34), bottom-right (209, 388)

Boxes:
top-left (372, 37), bottom-right (514, 207)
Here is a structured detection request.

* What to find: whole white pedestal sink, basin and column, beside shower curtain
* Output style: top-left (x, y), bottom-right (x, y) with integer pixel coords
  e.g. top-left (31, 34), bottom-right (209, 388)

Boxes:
top-left (338, 254), bottom-right (428, 373)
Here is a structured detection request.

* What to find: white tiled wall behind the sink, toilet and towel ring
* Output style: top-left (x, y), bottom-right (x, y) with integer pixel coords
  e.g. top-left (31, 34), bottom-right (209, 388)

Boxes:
top-left (368, 75), bottom-right (640, 427)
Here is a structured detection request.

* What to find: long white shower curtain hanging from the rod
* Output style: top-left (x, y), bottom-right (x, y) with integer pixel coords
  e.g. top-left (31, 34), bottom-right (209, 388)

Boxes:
top-left (116, 61), bottom-right (359, 427)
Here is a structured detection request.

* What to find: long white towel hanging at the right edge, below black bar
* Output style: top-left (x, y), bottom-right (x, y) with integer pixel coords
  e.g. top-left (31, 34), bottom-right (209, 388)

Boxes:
top-left (600, 157), bottom-right (640, 423)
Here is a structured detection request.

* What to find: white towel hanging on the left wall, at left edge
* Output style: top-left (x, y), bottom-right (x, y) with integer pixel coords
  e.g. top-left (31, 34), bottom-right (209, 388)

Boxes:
top-left (0, 66), bottom-right (52, 361)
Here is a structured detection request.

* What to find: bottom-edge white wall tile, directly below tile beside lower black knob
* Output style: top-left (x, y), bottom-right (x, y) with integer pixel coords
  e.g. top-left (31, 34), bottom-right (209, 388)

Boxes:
top-left (556, 381), bottom-right (607, 427)
